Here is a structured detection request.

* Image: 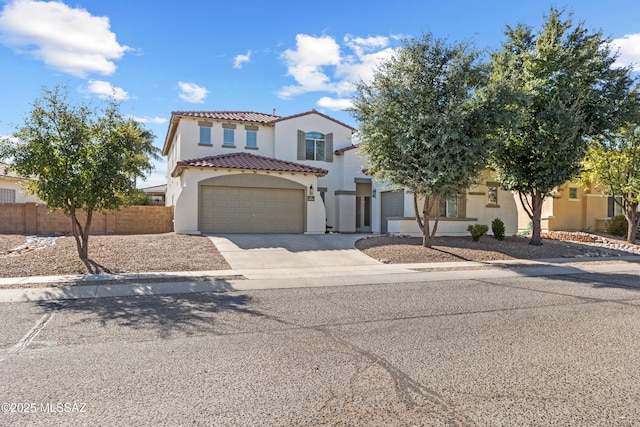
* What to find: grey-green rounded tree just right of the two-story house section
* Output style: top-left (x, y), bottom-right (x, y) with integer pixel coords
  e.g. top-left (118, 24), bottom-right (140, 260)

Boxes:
top-left (350, 34), bottom-right (486, 247)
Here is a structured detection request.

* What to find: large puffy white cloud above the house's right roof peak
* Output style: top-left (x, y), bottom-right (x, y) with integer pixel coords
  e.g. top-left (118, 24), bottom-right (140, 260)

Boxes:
top-left (278, 34), bottom-right (395, 100)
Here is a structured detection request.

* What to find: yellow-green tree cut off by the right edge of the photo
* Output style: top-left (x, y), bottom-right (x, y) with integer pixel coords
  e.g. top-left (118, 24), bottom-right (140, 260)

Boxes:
top-left (582, 126), bottom-right (640, 243)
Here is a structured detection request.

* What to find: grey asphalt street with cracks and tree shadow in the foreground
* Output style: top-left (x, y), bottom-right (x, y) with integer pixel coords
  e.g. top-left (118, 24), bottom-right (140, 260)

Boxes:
top-left (0, 271), bottom-right (640, 426)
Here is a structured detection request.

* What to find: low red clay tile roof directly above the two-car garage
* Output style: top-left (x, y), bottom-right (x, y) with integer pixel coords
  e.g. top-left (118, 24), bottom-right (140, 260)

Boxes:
top-left (171, 153), bottom-right (329, 176)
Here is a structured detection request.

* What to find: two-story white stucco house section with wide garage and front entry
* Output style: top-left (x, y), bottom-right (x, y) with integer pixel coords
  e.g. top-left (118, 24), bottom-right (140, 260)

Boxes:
top-left (162, 110), bottom-right (371, 234)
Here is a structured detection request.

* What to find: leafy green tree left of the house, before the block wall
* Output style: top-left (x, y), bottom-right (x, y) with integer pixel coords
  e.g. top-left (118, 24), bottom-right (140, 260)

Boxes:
top-left (0, 87), bottom-right (158, 261)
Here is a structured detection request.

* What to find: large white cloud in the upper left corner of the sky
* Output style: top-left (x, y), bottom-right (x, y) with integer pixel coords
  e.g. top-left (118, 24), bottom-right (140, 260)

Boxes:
top-left (0, 0), bottom-right (130, 77)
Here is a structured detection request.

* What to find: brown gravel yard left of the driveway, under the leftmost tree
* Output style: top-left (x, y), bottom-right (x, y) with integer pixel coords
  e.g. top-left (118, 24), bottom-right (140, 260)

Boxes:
top-left (0, 233), bottom-right (230, 277)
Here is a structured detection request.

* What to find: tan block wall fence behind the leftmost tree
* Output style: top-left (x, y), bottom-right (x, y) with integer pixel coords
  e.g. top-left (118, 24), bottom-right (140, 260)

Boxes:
top-left (0, 203), bottom-right (173, 235)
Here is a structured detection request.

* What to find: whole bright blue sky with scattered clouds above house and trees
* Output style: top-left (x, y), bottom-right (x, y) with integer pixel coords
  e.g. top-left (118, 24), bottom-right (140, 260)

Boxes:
top-left (0, 0), bottom-right (640, 186)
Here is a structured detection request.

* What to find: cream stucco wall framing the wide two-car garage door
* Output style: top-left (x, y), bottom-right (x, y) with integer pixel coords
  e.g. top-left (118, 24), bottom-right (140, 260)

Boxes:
top-left (172, 168), bottom-right (325, 234)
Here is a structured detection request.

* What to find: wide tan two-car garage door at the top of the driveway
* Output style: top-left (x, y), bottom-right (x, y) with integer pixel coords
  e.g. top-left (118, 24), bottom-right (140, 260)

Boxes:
top-left (200, 185), bottom-right (305, 233)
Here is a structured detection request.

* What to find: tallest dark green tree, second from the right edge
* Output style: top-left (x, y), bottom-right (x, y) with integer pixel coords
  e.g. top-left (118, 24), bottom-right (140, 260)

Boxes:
top-left (485, 8), bottom-right (632, 245)
